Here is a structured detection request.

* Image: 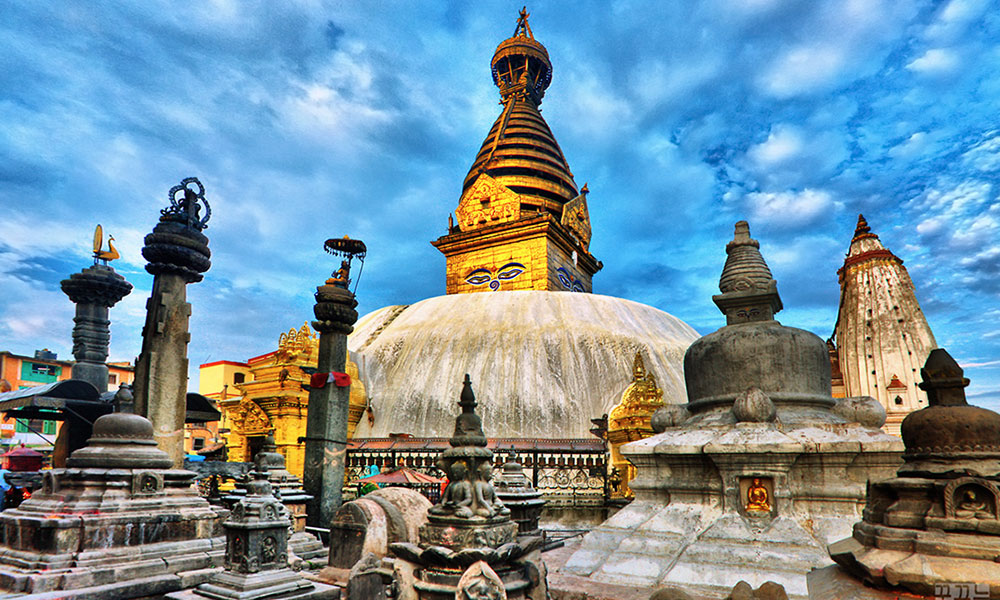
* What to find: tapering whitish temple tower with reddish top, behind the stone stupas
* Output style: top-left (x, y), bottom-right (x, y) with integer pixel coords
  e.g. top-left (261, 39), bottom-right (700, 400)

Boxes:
top-left (834, 215), bottom-right (937, 435)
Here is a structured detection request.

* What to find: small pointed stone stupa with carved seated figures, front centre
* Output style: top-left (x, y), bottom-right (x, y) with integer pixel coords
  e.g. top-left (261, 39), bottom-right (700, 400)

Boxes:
top-left (389, 375), bottom-right (547, 600)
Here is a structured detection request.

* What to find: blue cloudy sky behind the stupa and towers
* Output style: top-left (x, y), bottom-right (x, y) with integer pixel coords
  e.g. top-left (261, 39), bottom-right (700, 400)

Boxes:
top-left (0, 0), bottom-right (1000, 408)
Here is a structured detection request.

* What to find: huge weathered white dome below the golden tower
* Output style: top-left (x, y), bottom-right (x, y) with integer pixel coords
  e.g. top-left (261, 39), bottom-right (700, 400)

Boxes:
top-left (348, 291), bottom-right (699, 439)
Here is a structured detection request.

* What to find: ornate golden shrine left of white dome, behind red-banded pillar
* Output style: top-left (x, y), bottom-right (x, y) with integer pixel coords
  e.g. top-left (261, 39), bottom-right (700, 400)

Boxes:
top-left (218, 323), bottom-right (367, 477)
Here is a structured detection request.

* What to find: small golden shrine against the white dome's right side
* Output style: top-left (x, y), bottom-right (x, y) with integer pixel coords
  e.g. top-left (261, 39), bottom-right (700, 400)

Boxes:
top-left (608, 352), bottom-right (663, 498)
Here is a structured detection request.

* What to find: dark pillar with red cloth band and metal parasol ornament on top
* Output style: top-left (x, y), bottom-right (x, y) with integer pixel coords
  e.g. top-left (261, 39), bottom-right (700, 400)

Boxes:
top-left (302, 236), bottom-right (367, 527)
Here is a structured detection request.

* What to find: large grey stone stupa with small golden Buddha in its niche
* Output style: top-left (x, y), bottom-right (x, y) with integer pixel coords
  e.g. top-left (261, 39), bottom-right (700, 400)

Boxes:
top-left (564, 221), bottom-right (902, 598)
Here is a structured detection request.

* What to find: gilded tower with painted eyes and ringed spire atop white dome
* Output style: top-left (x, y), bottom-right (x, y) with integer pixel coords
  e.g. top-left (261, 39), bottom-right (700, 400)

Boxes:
top-left (431, 9), bottom-right (602, 294)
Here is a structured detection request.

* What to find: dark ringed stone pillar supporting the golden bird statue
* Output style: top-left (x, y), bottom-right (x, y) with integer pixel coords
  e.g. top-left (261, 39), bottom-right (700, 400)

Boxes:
top-left (56, 264), bottom-right (132, 466)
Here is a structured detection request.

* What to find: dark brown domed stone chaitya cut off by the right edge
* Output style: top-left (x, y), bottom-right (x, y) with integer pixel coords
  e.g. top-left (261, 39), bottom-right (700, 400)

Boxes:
top-left (829, 348), bottom-right (1000, 598)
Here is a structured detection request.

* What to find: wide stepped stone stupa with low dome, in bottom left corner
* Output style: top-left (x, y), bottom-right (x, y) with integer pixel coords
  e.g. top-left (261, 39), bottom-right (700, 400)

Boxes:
top-left (0, 413), bottom-right (225, 598)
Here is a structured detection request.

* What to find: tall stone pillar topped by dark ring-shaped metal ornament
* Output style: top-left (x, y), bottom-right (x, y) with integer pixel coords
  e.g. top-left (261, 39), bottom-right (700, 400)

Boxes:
top-left (134, 177), bottom-right (212, 468)
